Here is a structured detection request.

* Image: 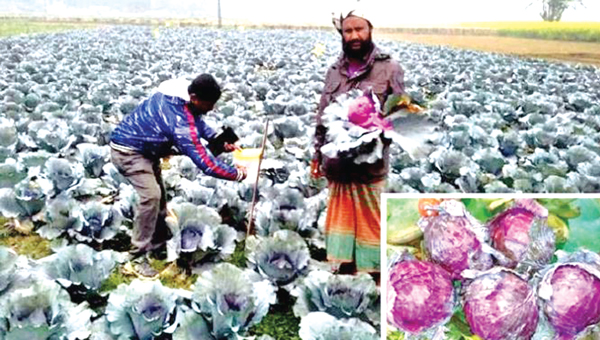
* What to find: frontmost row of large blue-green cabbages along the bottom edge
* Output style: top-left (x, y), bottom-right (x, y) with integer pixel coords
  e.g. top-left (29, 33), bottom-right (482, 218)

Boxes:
top-left (0, 239), bottom-right (380, 340)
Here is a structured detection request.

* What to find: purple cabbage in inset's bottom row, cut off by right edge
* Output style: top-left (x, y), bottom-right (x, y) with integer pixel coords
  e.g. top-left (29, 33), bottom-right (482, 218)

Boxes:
top-left (538, 251), bottom-right (600, 340)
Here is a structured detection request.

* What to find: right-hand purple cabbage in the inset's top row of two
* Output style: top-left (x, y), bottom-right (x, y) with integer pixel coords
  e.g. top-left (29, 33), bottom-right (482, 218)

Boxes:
top-left (488, 199), bottom-right (555, 269)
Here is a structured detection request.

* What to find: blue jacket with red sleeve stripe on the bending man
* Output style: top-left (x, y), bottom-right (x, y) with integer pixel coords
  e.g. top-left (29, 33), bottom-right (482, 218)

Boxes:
top-left (110, 92), bottom-right (243, 181)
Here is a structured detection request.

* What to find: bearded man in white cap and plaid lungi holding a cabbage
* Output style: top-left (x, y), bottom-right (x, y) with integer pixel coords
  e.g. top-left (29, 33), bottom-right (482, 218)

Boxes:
top-left (312, 11), bottom-right (404, 280)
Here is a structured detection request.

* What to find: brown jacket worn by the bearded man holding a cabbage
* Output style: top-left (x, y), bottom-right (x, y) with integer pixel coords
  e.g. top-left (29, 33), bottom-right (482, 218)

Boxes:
top-left (315, 47), bottom-right (404, 183)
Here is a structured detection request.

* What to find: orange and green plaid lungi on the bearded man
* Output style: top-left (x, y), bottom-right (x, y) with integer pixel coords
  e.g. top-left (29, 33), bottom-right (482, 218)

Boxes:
top-left (325, 181), bottom-right (385, 272)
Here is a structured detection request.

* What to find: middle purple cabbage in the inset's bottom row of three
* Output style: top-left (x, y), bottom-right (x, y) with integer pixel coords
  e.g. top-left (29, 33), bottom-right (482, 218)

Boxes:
top-left (464, 267), bottom-right (538, 340)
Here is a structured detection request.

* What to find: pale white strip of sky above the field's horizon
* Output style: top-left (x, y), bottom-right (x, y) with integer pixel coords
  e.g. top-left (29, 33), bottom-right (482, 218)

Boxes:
top-left (5, 0), bottom-right (600, 27)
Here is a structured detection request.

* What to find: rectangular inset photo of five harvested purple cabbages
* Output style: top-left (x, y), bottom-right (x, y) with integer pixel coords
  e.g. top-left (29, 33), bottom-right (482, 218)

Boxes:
top-left (381, 194), bottom-right (600, 340)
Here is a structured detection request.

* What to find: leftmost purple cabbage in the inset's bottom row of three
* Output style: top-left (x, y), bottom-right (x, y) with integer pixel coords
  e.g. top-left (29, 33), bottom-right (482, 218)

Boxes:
top-left (387, 260), bottom-right (455, 334)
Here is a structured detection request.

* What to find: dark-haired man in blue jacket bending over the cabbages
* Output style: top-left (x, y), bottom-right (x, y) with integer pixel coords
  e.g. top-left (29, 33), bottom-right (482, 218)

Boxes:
top-left (110, 74), bottom-right (246, 264)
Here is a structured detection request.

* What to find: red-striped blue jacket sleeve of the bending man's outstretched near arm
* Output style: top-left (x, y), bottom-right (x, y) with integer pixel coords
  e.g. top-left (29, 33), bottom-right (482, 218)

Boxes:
top-left (174, 113), bottom-right (243, 181)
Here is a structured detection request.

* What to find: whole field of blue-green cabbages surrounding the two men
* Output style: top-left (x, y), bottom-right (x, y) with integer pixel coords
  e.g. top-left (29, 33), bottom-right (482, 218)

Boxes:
top-left (0, 26), bottom-right (600, 340)
